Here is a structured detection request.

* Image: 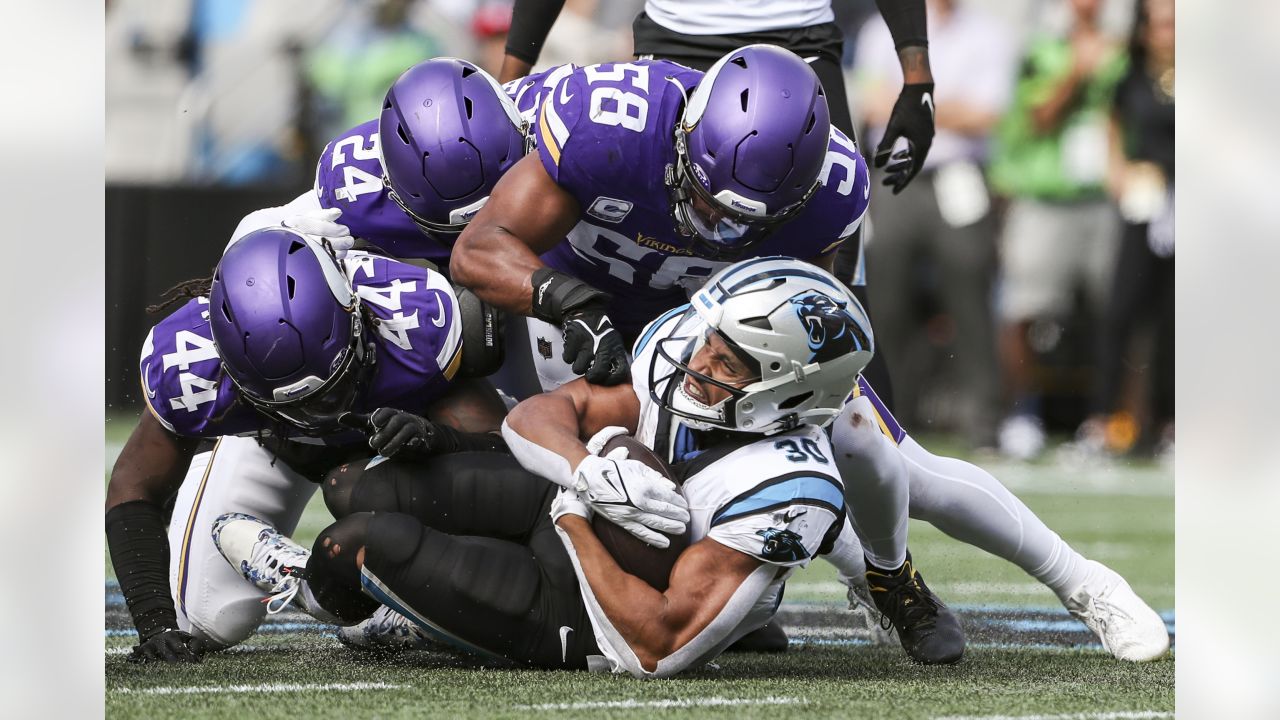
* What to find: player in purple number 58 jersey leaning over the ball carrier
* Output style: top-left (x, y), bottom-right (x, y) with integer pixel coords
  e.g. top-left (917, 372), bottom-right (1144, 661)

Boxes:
top-left (451, 46), bottom-right (1169, 660)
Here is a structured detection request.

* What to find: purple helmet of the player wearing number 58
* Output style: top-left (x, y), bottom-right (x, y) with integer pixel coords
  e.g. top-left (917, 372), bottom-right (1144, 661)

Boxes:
top-left (666, 45), bottom-right (831, 260)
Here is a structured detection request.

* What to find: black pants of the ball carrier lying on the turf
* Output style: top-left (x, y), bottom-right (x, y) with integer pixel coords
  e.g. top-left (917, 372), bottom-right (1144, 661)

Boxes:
top-left (307, 452), bottom-right (599, 669)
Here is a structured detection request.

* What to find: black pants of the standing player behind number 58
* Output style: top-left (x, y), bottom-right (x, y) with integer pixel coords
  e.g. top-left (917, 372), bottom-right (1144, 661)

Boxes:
top-left (631, 13), bottom-right (893, 410)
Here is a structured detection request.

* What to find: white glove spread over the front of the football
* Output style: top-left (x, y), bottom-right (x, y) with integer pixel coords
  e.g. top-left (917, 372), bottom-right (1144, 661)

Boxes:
top-left (573, 447), bottom-right (689, 547)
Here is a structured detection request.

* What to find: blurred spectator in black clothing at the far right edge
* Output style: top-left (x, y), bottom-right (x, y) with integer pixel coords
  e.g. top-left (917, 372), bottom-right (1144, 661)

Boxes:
top-left (1078, 0), bottom-right (1174, 452)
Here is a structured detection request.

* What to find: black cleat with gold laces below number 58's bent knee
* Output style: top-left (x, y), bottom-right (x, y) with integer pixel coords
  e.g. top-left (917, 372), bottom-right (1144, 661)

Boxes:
top-left (867, 552), bottom-right (965, 665)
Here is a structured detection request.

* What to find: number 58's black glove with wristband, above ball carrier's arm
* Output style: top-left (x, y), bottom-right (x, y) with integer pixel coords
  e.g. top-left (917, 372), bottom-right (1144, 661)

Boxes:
top-left (530, 268), bottom-right (631, 386)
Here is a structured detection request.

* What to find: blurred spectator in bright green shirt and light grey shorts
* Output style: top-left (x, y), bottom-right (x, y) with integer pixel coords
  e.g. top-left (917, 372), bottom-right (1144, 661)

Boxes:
top-left (991, 0), bottom-right (1126, 459)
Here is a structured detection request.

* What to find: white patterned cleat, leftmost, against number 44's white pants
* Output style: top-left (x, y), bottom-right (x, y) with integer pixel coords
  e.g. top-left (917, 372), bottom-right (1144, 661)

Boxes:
top-left (212, 512), bottom-right (311, 615)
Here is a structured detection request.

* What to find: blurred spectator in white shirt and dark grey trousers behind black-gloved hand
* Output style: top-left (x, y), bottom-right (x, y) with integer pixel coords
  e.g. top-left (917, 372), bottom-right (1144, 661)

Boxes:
top-left (855, 0), bottom-right (1015, 448)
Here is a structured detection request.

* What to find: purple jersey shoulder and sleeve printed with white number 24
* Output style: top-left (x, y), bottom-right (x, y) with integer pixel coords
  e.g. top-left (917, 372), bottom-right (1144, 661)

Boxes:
top-left (315, 120), bottom-right (449, 268)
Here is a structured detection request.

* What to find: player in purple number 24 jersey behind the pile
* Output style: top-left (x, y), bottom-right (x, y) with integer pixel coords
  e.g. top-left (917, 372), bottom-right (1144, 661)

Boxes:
top-left (232, 58), bottom-right (554, 269)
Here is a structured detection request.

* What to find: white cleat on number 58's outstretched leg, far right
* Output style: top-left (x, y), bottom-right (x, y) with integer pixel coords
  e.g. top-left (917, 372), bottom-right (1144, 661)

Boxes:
top-left (1062, 560), bottom-right (1169, 662)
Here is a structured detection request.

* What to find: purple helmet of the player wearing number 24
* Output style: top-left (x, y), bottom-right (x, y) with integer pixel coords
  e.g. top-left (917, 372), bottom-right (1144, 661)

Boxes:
top-left (378, 58), bottom-right (525, 242)
